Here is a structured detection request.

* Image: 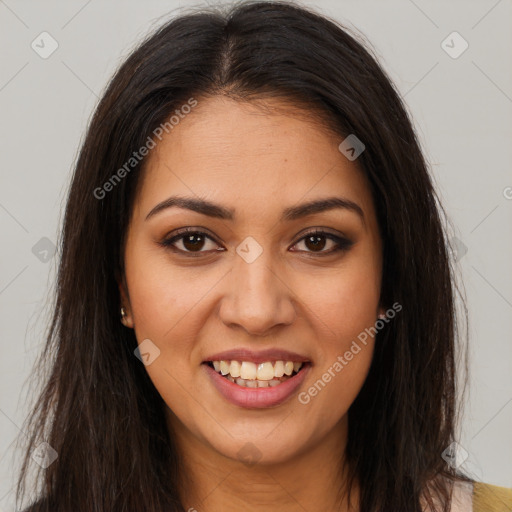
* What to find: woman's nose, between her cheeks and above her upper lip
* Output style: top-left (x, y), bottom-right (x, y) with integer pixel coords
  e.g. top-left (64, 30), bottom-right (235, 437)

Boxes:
top-left (219, 251), bottom-right (296, 336)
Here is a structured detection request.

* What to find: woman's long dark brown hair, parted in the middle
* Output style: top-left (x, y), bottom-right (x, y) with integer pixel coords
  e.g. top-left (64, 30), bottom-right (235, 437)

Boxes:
top-left (17, 2), bottom-right (467, 512)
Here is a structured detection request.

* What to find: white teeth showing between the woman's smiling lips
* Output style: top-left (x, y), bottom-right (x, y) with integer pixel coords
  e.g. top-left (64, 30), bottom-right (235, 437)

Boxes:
top-left (203, 360), bottom-right (310, 388)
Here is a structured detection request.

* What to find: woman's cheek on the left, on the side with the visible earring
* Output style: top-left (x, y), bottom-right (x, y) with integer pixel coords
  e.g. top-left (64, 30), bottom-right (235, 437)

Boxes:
top-left (125, 249), bottom-right (211, 396)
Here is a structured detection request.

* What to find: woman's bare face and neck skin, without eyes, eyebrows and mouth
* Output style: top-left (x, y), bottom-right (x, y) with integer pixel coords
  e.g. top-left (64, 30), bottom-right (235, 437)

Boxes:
top-left (119, 97), bottom-right (384, 512)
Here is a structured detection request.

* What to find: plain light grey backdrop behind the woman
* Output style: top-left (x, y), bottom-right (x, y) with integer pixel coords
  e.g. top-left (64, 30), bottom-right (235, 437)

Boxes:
top-left (0, 0), bottom-right (512, 511)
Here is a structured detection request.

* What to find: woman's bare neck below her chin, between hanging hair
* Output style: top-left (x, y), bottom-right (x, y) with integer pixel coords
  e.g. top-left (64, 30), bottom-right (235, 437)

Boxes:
top-left (173, 417), bottom-right (359, 512)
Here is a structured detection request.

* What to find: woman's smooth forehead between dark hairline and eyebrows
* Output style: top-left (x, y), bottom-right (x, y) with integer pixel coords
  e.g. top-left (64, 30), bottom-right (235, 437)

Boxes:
top-left (135, 97), bottom-right (373, 224)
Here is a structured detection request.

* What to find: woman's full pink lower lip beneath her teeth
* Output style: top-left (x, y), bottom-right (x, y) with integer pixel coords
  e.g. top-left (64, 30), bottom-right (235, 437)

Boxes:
top-left (202, 363), bottom-right (311, 409)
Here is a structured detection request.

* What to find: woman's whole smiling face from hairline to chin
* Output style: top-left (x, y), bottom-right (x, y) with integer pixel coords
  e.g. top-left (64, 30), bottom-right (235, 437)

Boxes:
top-left (120, 97), bottom-right (382, 463)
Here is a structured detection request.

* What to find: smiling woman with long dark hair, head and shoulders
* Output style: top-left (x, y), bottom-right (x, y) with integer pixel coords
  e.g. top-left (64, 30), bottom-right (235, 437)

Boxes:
top-left (18, 2), bottom-right (510, 512)
